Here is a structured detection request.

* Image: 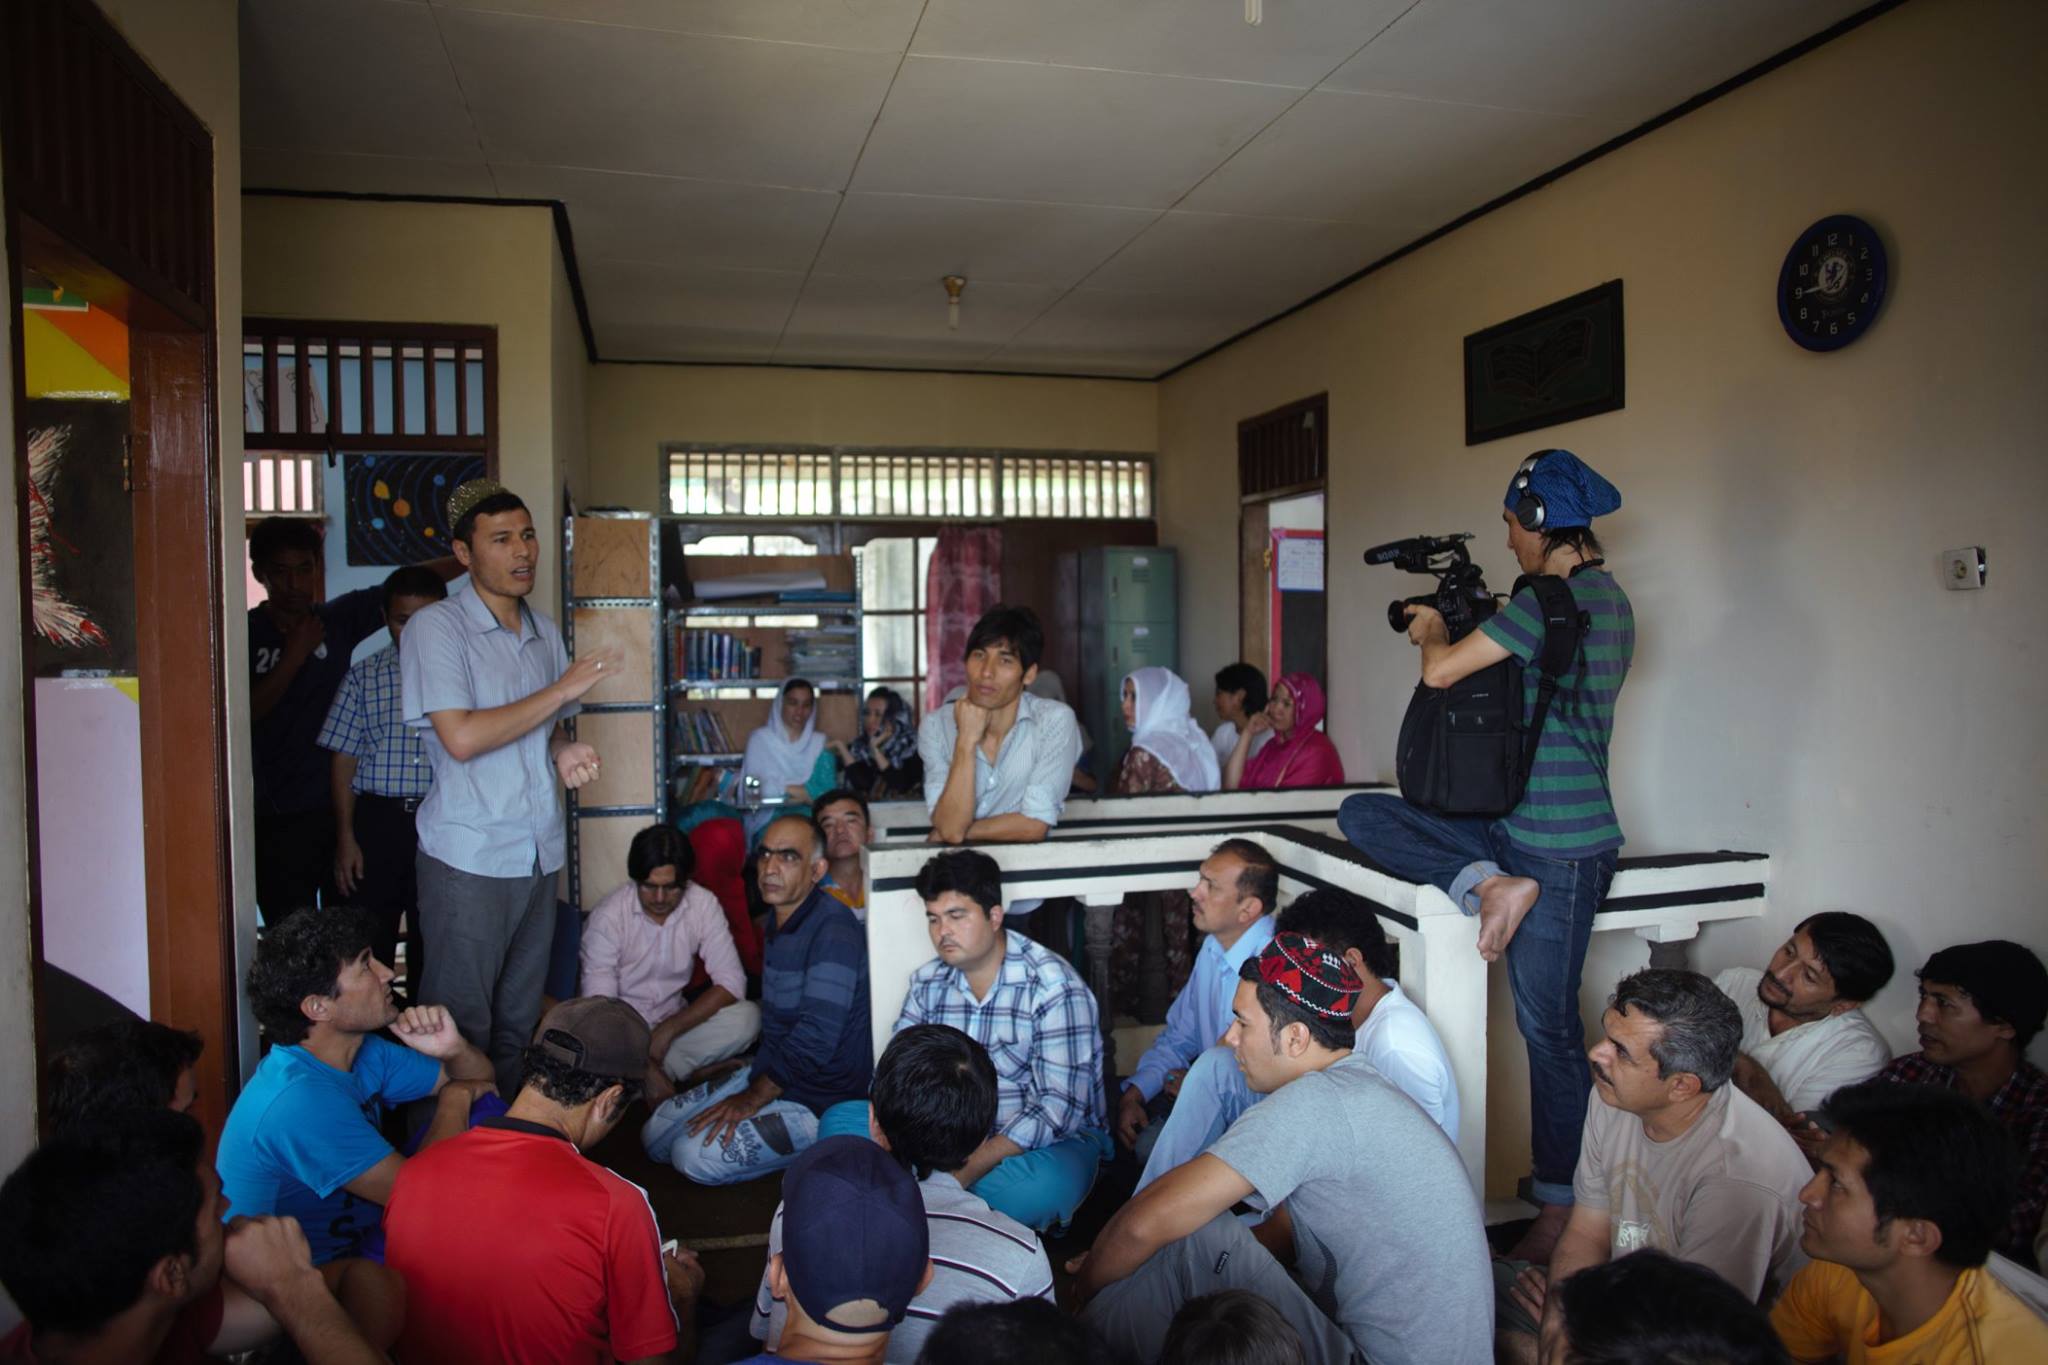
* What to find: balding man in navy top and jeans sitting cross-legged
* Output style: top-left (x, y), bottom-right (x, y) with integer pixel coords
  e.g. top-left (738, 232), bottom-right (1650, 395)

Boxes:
top-left (641, 814), bottom-right (874, 1185)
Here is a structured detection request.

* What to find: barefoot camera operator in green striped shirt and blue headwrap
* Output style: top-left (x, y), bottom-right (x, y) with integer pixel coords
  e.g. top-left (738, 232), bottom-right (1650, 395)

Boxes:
top-left (1337, 450), bottom-right (1636, 1263)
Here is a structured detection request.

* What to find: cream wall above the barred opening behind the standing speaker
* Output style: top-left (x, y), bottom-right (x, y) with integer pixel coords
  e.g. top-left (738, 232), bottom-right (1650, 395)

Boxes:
top-left (242, 196), bottom-right (580, 614)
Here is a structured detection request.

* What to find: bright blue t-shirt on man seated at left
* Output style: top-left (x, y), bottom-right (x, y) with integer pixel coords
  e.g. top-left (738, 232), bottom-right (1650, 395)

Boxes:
top-left (215, 1038), bottom-right (440, 1265)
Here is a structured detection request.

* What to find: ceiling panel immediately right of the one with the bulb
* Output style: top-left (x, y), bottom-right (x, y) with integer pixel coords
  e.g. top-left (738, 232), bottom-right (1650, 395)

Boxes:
top-left (1087, 211), bottom-right (1413, 299)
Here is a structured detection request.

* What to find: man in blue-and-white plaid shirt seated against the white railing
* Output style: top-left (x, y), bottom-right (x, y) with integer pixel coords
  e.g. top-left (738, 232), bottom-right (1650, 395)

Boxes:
top-left (819, 849), bottom-right (1114, 1232)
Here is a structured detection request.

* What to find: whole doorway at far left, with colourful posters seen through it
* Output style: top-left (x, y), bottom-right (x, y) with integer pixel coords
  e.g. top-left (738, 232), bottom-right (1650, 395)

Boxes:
top-left (0, 0), bottom-right (240, 1126)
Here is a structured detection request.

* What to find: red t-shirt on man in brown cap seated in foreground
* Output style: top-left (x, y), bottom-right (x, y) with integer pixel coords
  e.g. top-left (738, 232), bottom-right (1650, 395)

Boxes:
top-left (385, 1117), bottom-right (676, 1365)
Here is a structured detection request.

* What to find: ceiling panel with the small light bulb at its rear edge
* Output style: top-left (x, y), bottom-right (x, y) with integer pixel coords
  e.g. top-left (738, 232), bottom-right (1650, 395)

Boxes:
top-left (817, 194), bottom-right (1159, 287)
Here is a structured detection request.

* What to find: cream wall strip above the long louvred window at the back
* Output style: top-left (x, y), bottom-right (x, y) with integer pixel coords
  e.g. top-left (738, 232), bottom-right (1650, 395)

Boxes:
top-left (590, 364), bottom-right (1159, 512)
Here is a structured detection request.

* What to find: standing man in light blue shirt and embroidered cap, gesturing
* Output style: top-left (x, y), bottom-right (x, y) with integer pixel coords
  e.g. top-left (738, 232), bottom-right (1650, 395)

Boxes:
top-left (399, 479), bottom-right (618, 1095)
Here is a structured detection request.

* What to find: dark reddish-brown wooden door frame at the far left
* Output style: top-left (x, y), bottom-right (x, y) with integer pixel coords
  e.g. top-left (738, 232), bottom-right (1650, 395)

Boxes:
top-left (0, 0), bottom-right (242, 1121)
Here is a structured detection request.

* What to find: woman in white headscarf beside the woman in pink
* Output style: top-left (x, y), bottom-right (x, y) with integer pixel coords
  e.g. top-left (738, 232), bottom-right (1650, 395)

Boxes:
top-left (1110, 667), bottom-right (1223, 1023)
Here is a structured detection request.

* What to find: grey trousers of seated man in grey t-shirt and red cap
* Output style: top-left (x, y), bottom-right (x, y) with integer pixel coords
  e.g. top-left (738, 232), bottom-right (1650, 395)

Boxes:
top-left (1081, 1214), bottom-right (1364, 1365)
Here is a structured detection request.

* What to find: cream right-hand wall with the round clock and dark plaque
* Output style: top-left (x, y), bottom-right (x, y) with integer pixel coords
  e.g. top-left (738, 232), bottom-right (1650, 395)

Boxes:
top-left (1159, 0), bottom-right (2048, 1195)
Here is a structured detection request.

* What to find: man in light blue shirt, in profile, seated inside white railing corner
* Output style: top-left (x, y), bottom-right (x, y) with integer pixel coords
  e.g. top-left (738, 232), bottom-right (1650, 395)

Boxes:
top-left (1116, 839), bottom-right (1280, 1166)
